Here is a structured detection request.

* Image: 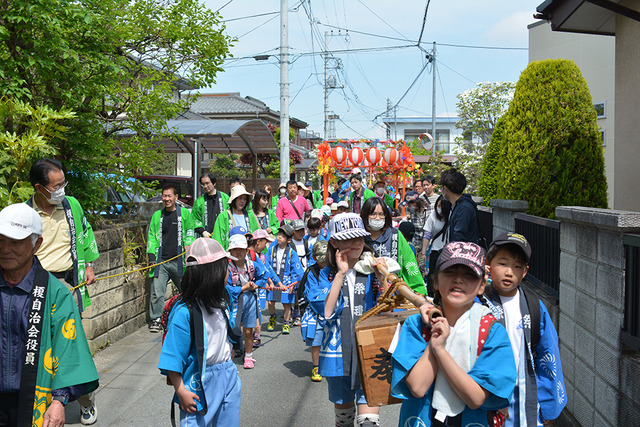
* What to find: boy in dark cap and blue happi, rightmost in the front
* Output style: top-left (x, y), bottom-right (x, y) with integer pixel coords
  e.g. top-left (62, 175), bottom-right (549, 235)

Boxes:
top-left (485, 233), bottom-right (567, 426)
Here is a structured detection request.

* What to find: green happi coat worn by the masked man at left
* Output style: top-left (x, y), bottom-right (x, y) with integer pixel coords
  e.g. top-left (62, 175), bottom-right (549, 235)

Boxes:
top-left (26, 196), bottom-right (100, 309)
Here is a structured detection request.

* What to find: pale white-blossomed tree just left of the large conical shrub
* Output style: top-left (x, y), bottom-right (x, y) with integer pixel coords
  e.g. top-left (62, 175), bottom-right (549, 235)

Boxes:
top-left (453, 82), bottom-right (515, 194)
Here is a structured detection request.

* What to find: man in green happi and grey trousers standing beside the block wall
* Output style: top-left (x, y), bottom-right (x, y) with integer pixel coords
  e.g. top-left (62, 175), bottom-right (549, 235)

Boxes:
top-left (147, 184), bottom-right (194, 332)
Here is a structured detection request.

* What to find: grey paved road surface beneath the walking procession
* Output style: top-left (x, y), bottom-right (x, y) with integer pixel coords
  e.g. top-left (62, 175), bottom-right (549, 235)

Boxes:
top-left (67, 310), bottom-right (400, 427)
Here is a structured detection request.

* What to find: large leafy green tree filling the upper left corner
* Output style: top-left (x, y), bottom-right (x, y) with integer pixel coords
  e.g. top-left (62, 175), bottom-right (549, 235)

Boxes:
top-left (0, 0), bottom-right (232, 211)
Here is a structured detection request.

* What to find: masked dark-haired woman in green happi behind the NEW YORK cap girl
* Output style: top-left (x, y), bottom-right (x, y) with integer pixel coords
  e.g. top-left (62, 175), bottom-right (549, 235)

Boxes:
top-left (360, 197), bottom-right (427, 294)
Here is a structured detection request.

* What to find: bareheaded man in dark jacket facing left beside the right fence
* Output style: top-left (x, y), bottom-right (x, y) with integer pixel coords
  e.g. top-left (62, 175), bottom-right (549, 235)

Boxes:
top-left (440, 168), bottom-right (479, 243)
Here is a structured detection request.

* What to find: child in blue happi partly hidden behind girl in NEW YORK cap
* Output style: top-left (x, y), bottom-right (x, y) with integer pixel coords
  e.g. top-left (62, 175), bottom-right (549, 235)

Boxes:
top-left (298, 240), bottom-right (329, 382)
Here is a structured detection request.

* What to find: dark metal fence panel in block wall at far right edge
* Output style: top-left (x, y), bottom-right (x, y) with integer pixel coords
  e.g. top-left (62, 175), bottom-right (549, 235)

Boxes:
top-left (620, 234), bottom-right (640, 350)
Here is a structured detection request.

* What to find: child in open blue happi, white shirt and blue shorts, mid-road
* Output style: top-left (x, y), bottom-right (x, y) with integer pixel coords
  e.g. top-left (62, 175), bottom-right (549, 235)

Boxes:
top-left (267, 224), bottom-right (304, 335)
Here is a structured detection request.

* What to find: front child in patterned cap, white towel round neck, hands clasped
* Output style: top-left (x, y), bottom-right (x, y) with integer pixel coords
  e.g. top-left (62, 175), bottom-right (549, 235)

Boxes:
top-left (391, 242), bottom-right (516, 427)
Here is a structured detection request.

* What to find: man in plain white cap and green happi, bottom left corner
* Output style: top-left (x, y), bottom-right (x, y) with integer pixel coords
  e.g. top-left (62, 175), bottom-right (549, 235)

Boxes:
top-left (0, 203), bottom-right (98, 427)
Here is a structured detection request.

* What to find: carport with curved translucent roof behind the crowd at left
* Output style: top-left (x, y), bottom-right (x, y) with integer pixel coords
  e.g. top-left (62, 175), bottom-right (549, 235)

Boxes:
top-left (118, 119), bottom-right (280, 199)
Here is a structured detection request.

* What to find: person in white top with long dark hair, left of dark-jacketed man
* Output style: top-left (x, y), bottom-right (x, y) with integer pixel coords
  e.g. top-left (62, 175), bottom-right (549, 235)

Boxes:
top-left (420, 195), bottom-right (451, 295)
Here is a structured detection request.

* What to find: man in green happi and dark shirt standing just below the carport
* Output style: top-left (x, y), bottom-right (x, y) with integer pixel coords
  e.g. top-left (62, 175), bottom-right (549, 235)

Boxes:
top-left (191, 172), bottom-right (229, 237)
